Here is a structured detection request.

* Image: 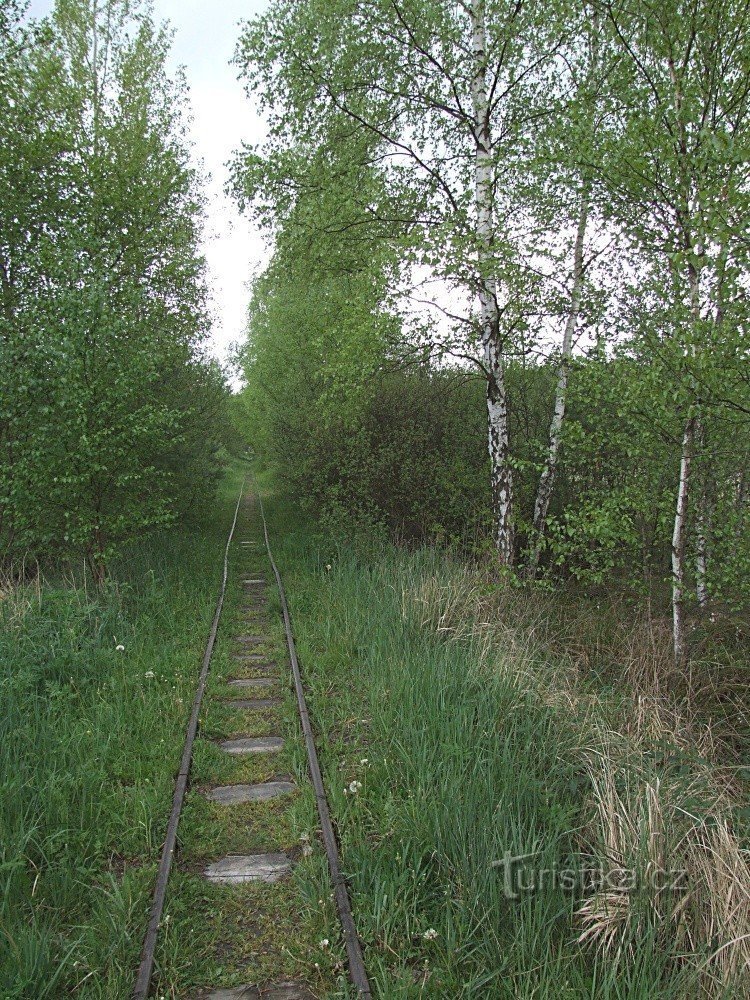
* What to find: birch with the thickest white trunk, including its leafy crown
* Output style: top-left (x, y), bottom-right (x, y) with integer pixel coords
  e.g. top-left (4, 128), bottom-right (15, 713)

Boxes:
top-left (238, 0), bottom-right (562, 565)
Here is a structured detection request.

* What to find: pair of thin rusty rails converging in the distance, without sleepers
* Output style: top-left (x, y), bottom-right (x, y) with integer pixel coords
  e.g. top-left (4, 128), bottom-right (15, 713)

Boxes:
top-left (132, 480), bottom-right (372, 1000)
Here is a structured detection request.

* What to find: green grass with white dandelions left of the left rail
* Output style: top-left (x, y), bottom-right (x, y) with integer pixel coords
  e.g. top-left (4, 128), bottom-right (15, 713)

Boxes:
top-left (0, 472), bottom-right (241, 1000)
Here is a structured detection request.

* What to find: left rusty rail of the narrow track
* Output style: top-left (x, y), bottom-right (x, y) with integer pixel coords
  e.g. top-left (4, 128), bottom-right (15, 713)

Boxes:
top-left (132, 479), bottom-right (245, 1000)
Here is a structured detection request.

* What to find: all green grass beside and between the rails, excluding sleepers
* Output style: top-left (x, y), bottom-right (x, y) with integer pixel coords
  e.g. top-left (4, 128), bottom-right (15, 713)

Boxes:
top-left (0, 476), bottom-right (742, 1000)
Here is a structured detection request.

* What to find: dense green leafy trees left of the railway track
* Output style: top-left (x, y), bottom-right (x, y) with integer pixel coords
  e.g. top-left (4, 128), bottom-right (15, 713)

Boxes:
top-left (0, 0), bottom-right (225, 579)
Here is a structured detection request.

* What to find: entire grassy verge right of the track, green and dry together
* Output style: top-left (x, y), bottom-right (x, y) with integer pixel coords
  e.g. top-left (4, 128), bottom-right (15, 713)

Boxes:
top-left (268, 511), bottom-right (750, 1000)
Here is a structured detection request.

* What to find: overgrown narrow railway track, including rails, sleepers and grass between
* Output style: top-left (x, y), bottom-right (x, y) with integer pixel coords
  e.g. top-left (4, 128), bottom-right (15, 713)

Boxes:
top-left (133, 485), bottom-right (370, 1000)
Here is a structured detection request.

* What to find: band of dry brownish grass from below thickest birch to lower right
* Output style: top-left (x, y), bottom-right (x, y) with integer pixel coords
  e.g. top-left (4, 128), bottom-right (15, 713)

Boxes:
top-left (402, 561), bottom-right (750, 997)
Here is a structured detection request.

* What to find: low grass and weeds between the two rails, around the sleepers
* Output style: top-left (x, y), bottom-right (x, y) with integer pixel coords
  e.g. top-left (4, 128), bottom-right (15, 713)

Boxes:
top-left (148, 482), bottom-right (331, 1000)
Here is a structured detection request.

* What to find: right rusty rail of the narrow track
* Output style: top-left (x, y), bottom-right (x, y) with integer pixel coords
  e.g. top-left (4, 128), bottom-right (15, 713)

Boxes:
top-left (255, 487), bottom-right (372, 997)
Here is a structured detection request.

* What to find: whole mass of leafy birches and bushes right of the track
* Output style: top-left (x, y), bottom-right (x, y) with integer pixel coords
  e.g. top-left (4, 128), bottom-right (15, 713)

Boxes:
top-left (235, 0), bottom-right (750, 640)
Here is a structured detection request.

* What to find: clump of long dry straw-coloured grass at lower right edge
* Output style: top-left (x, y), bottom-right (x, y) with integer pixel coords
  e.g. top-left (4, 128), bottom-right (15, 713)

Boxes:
top-left (576, 734), bottom-right (750, 996)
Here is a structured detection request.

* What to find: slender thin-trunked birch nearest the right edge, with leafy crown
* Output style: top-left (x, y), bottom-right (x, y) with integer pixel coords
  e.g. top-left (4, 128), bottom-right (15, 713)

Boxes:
top-left (601, 0), bottom-right (750, 662)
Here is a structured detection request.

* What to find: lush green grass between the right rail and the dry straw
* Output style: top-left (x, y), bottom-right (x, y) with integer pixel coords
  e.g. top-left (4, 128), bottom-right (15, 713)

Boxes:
top-left (270, 496), bottom-right (742, 1000)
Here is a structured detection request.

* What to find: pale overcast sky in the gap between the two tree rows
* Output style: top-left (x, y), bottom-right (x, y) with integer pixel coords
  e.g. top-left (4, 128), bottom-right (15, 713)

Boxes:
top-left (30, 0), bottom-right (268, 370)
